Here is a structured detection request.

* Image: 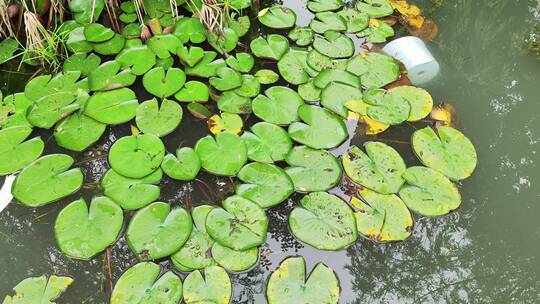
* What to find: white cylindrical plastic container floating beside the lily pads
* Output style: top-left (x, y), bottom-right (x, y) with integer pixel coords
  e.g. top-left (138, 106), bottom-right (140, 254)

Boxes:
top-left (383, 36), bottom-right (440, 85)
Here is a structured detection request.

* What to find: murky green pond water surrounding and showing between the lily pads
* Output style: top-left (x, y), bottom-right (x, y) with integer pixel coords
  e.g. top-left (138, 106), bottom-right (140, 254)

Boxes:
top-left (0, 0), bottom-right (540, 304)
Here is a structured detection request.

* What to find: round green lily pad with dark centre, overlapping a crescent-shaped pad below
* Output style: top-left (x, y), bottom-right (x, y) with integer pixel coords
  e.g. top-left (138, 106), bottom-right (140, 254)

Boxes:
top-left (206, 195), bottom-right (268, 250)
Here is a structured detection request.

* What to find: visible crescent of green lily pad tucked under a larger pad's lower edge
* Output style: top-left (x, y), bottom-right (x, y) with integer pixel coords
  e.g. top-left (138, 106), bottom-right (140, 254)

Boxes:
top-left (212, 243), bottom-right (259, 272)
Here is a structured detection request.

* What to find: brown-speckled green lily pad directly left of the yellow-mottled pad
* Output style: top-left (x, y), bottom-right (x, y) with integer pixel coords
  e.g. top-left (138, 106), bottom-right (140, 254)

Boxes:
top-left (289, 192), bottom-right (357, 250)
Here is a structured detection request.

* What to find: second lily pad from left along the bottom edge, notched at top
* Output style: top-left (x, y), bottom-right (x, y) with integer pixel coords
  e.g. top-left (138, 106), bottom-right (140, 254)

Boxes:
top-left (111, 262), bottom-right (182, 304)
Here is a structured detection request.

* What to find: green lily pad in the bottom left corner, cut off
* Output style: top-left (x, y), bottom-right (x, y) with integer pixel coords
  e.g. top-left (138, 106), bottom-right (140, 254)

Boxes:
top-left (2, 275), bottom-right (73, 304)
